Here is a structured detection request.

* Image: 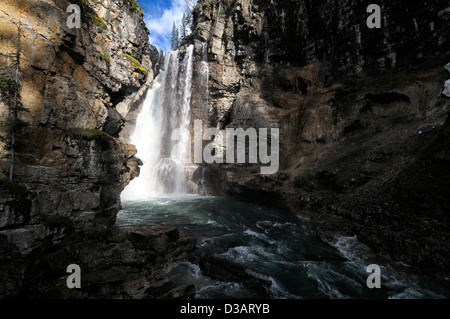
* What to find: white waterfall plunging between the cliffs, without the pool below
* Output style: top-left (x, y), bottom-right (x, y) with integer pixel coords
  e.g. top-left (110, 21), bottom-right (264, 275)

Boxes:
top-left (122, 45), bottom-right (194, 200)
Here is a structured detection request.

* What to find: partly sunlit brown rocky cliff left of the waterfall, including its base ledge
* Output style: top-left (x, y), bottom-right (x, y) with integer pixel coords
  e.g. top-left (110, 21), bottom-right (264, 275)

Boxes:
top-left (0, 0), bottom-right (193, 298)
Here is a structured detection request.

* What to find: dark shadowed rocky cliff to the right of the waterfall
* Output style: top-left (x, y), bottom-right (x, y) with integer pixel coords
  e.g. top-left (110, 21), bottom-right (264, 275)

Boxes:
top-left (188, 0), bottom-right (450, 275)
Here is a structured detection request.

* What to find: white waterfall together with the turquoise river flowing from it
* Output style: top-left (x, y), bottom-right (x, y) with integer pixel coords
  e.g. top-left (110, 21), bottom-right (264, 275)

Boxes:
top-left (117, 44), bottom-right (445, 299)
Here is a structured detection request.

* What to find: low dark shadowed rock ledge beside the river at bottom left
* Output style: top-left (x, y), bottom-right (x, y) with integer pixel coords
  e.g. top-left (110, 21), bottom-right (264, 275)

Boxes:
top-left (11, 225), bottom-right (196, 299)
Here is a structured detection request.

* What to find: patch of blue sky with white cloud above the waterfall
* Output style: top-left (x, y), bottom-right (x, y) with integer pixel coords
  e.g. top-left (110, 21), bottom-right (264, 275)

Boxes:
top-left (138, 0), bottom-right (186, 52)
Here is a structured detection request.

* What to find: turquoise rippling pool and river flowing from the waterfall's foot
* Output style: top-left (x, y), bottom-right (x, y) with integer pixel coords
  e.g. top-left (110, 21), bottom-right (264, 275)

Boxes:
top-left (117, 195), bottom-right (446, 299)
